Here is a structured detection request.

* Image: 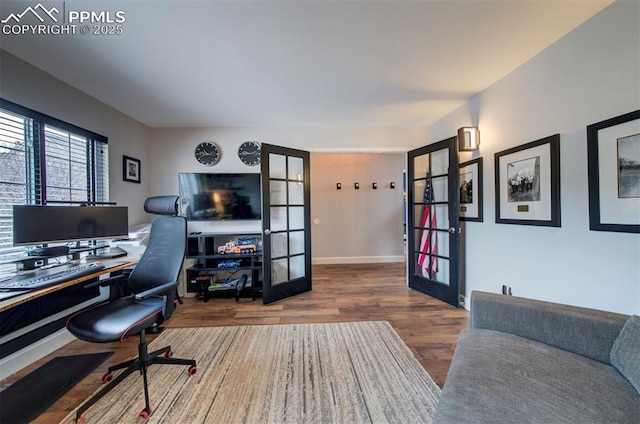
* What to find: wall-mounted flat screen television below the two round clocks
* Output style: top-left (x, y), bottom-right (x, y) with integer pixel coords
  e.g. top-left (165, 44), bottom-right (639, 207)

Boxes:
top-left (178, 172), bottom-right (262, 221)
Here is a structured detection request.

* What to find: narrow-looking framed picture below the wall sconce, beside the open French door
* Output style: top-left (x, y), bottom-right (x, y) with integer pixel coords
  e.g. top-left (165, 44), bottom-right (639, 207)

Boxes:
top-left (459, 158), bottom-right (483, 222)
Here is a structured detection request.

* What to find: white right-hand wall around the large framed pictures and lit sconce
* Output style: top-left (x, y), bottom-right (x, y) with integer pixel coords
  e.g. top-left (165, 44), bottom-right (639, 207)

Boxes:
top-left (429, 1), bottom-right (640, 314)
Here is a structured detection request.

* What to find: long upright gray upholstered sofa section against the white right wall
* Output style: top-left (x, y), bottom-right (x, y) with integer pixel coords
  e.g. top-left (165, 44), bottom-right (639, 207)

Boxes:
top-left (470, 291), bottom-right (629, 364)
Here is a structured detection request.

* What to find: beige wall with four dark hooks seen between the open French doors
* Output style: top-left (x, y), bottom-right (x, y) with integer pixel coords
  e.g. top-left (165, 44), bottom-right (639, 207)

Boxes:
top-left (311, 153), bottom-right (406, 263)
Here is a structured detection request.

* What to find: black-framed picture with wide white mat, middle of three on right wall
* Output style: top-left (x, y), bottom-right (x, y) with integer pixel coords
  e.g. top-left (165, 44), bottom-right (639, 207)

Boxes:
top-left (495, 134), bottom-right (561, 227)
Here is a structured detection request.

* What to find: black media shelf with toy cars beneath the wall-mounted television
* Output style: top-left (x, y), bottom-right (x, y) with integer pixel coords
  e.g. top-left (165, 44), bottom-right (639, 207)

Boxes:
top-left (186, 233), bottom-right (262, 302)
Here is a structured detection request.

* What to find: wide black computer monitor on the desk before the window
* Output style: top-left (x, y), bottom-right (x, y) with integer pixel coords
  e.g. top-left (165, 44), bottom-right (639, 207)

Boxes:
top-left (13, 205), bottom-right (129, 246)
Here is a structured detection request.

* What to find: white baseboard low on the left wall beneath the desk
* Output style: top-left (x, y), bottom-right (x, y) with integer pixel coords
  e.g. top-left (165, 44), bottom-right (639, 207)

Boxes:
top-left (0, 328), bottom-right (75, 380)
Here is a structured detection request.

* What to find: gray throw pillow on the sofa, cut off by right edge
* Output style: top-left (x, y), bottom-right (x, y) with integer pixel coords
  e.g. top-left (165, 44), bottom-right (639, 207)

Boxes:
top-left (611, 315), bottom-right (640, 393)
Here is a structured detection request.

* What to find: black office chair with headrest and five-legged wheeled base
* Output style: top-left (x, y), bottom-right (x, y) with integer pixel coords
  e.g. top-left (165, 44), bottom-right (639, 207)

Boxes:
top-left (67, 196), bottom-right (197, 422)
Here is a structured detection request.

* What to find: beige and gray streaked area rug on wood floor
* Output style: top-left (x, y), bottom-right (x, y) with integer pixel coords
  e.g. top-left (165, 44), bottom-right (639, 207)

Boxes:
top-left (63, 321), bottom-right (440, 424)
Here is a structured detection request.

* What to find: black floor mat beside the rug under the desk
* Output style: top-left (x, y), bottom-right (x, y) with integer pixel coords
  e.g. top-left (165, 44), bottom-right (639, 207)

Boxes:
top-left (0, 352), bottom-right (113, 424)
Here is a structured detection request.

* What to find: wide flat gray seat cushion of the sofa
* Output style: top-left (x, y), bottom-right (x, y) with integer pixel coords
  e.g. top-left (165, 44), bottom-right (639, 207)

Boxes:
top-left (434, 329), bottom-right (640, 424)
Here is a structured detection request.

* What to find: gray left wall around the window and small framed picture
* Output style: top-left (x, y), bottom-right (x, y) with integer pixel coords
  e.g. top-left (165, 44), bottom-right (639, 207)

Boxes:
top-left (0, 50), bottom-right (151, 225)
